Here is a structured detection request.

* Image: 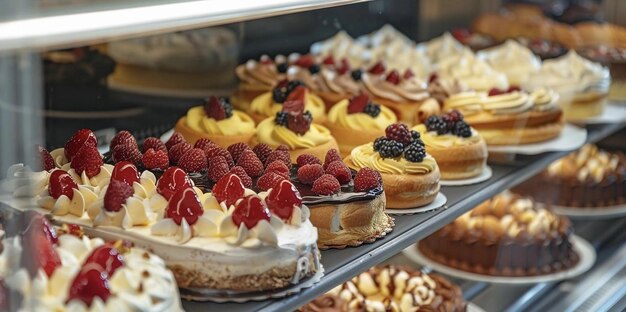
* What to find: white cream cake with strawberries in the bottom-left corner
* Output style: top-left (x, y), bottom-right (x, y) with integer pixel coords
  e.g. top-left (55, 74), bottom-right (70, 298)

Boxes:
top-left (0, 212), bottom-right (182, 312)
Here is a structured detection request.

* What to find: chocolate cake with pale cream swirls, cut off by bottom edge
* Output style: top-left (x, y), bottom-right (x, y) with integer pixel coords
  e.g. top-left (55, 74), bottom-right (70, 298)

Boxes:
top-left (299, 265), bottom-right (467, 312)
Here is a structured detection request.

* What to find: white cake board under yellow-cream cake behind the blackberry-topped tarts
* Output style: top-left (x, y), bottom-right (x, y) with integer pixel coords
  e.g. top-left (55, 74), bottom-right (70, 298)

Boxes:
top-left (487, 123), bottom-right (587, 155)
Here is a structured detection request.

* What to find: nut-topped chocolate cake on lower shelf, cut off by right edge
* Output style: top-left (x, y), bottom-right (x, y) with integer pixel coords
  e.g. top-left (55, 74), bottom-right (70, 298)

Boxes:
top-left (513, 144), bottom-right (626, 209)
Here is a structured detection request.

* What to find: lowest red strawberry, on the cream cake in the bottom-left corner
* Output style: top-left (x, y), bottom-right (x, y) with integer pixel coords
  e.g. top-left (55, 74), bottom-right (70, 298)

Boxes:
top-left (67, 265), bottom-right (111, 306)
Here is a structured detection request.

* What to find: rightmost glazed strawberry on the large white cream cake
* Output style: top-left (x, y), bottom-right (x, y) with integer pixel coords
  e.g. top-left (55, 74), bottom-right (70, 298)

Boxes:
top-left (265, 180), bottom-right (302, 221)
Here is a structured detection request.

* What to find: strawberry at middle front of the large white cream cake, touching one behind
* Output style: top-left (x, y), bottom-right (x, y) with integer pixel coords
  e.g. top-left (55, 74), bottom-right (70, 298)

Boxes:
top-left (165, 187), bottom-right (204, 225)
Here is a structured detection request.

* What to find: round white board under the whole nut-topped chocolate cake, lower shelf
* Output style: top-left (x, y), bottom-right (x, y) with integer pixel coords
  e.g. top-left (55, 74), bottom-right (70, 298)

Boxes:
top-left (402, 235), bottom-right (596, 285)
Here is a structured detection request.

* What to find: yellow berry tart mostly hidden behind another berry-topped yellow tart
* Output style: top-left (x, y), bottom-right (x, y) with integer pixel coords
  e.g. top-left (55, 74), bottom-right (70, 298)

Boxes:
top-left (250, 80), bottom-right (326, 123)
